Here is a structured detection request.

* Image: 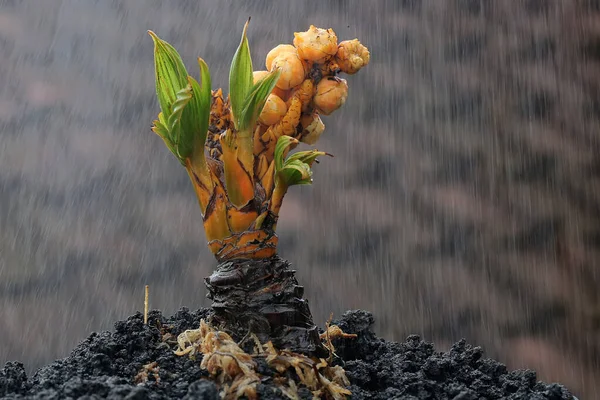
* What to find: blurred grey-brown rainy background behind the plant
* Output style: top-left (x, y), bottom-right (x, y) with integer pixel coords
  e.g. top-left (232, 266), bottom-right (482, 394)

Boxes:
top-left (0, 0), bottom-right (600, 399)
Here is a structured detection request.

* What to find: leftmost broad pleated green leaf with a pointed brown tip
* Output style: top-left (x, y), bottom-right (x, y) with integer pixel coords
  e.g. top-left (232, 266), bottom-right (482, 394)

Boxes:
top-left (148, 31), bottom-right (188, 118)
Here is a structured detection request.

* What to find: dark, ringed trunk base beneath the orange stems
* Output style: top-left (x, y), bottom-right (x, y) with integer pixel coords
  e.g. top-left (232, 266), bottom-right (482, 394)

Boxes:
top-left (205, 256), bottom-right (328, 357)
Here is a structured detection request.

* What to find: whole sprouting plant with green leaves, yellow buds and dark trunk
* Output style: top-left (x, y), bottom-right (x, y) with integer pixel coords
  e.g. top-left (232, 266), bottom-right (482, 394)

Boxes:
top-left (149, 20), bottom-right (370, 355)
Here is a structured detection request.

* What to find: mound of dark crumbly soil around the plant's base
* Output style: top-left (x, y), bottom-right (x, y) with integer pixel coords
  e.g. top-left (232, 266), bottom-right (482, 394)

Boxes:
top-left (0, 308), bottom-right (573, 400)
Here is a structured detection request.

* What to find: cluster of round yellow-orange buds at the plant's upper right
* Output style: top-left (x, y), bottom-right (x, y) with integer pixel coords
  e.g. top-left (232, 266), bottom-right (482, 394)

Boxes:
top-left (254, 25), bottom-right (370, 144)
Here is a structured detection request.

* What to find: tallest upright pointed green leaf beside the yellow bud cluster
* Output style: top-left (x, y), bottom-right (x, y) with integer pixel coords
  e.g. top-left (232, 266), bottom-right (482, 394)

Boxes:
top-left (229, 19), bottom-right (254, 130)
